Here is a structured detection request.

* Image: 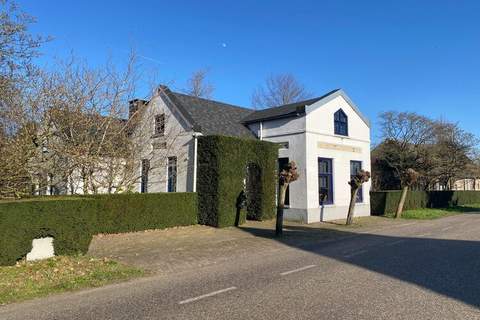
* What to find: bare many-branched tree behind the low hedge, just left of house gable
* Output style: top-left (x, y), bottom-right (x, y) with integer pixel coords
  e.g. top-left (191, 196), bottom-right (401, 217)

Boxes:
top-left (28, 55), bottom-right (135, 193)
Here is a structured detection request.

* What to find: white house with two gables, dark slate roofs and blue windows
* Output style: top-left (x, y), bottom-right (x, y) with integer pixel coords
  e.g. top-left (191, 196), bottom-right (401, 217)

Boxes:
top-left (130, 86), bottom-right (370, 223)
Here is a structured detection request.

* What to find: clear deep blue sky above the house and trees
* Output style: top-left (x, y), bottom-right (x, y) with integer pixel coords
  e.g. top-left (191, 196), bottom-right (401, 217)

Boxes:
top-left (18, 0), bottom-right (480, 141)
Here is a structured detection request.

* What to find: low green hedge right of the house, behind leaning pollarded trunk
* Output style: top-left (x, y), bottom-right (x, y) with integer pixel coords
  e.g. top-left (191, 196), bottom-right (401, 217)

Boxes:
top-left (370, 191), bottom-right (480, 215)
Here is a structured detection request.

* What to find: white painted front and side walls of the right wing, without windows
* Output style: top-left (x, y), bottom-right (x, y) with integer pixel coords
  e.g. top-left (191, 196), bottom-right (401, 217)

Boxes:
top-left (255, 95), bottom-right (371, 223)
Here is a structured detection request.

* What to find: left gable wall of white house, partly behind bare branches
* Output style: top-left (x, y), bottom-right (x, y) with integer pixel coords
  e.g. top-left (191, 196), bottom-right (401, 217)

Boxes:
top-left (130, 95), bottom-right (194, 192)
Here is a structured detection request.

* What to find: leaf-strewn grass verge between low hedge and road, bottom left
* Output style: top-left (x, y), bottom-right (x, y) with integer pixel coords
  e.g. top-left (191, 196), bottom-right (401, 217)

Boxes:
top-left (0, 256), bottom-right (143, 305)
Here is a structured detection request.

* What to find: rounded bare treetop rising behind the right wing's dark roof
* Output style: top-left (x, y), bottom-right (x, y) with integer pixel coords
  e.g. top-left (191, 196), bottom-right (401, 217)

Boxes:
top-left (252, 73), bottom-right (311, 108)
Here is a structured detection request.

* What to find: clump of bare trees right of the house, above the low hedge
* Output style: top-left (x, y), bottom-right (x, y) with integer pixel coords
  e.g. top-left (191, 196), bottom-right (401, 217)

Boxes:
top-left (372, 113), bottom-right (478, 195)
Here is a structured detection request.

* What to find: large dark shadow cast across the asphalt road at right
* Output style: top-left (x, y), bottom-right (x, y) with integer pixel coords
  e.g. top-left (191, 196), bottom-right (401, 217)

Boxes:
top-left (240, 221), bottom-right (480, 307)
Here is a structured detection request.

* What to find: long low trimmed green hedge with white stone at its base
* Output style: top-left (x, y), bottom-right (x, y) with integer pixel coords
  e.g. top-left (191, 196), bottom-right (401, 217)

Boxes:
top-left (0, 193), bottom-right (197, 265)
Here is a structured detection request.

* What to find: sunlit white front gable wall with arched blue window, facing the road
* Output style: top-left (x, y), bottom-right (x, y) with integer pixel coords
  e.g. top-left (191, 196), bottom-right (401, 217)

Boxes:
top-left (304, 95), bottom-right (370, 222)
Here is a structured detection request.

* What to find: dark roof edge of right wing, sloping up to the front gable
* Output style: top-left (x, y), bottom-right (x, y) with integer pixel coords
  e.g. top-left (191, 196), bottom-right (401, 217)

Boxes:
top-left (243, 89), bottom-right (340, 124)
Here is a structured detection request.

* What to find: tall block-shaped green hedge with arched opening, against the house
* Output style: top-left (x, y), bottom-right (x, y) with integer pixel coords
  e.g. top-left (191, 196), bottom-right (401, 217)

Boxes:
top-left (197, 136), bottom-right (278, 227)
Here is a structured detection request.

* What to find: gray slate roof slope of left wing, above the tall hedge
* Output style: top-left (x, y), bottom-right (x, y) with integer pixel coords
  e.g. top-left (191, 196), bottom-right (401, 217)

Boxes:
top-left (161, 86), bottom-right (255, 138)
